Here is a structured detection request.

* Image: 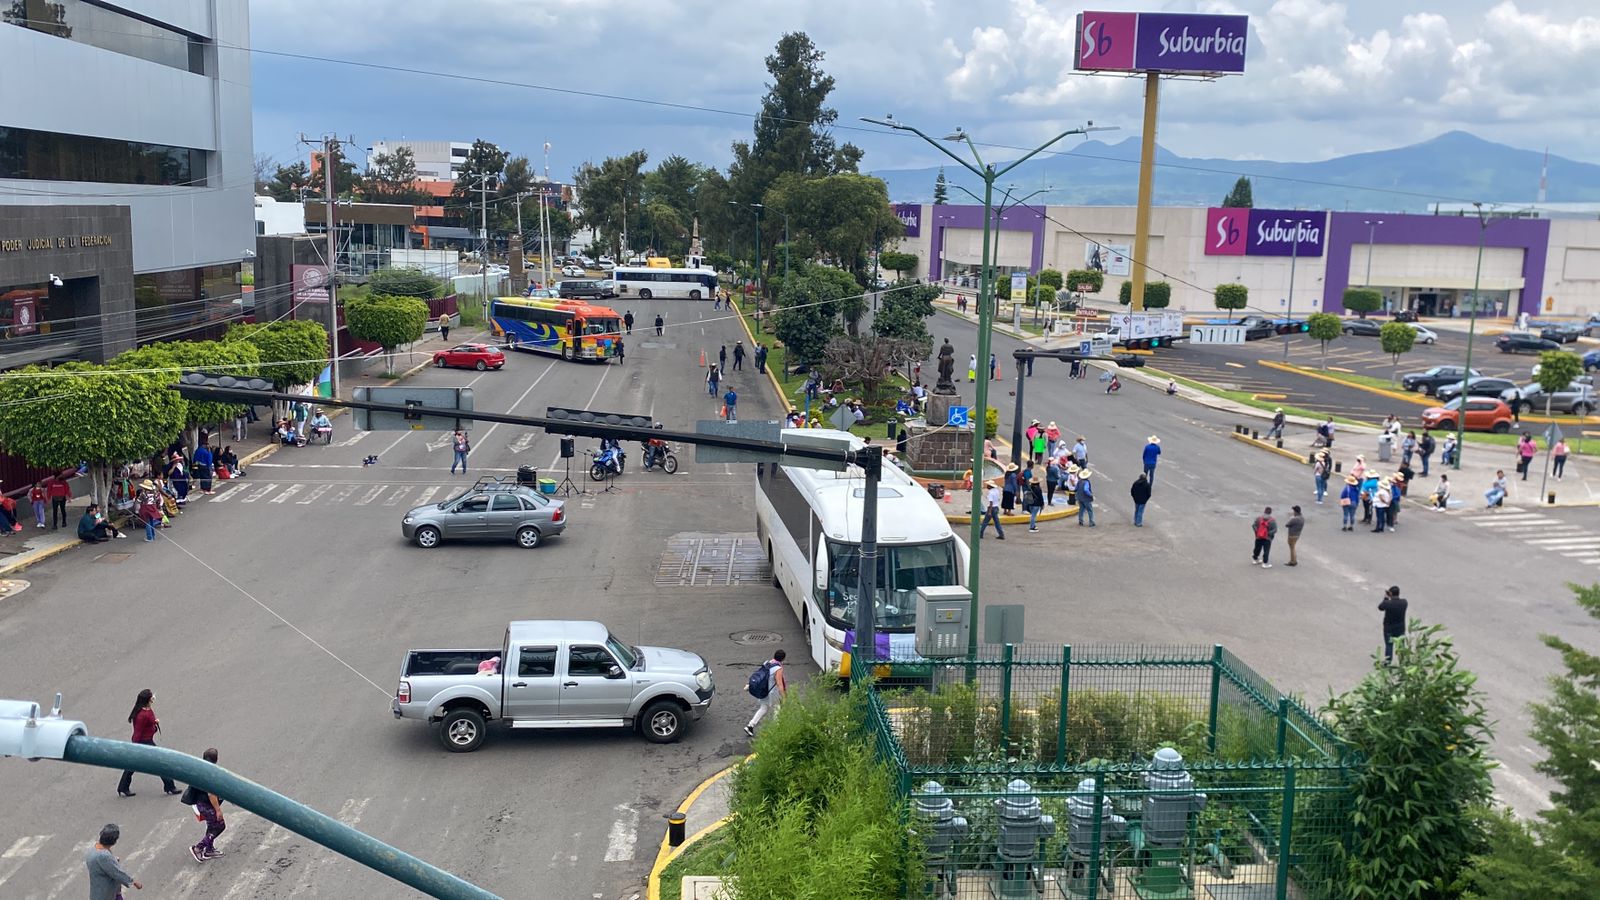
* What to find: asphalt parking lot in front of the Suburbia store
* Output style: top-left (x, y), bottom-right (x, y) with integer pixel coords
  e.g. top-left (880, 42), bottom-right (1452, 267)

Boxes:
top-left (1150, 331), bottom-right (1587, 428)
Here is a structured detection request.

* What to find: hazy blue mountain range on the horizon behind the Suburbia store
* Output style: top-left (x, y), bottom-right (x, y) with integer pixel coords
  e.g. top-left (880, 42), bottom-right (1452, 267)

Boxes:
top-left (872, 131), bottom-right (1600, 213)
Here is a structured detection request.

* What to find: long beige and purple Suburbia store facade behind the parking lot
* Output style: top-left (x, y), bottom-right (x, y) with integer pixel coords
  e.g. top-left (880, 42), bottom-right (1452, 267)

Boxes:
top-left (894, 203), bottom-right (1600, 317)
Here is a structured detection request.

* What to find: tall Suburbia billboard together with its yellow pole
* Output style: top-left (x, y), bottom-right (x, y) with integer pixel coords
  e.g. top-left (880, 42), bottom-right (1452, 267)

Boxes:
top-left (1074, 13), bottom-right (1250, 312)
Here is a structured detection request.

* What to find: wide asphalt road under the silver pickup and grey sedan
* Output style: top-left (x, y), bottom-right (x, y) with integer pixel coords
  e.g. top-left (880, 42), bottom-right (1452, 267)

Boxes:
top-left (0, 301), bottom-right (806, 900)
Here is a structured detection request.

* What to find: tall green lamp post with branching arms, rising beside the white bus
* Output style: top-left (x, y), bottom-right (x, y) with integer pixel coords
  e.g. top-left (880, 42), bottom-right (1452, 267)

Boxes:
top-left (862, 115), bottom-right (1112, 660)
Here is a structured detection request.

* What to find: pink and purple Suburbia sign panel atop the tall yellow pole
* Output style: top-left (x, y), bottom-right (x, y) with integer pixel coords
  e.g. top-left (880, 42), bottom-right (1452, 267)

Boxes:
top-left (1072, 13), bottom-right (1250, 75)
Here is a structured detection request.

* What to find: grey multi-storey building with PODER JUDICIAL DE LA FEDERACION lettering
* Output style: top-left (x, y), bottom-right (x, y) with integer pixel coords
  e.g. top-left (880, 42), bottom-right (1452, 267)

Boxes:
top-left (0, 0), bottom-right (254, 368)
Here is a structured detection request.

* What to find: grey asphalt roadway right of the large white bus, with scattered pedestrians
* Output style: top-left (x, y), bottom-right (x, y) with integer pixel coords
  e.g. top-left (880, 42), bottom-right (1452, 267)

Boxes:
top-left (930, 307), bottom-right (1600, 812)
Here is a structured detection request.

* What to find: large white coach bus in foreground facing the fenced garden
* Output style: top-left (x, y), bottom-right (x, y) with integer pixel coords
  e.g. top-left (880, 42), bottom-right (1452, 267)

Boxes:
top-left (755, 429), bottom-right (968, 676)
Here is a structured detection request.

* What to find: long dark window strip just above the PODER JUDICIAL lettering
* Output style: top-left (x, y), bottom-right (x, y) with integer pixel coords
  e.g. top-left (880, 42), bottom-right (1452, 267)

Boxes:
top-left (0, 127), bottom-right (206, 186)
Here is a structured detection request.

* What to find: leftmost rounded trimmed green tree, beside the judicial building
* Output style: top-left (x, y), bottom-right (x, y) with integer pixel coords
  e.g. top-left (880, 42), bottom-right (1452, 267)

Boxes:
top-left (0, 362), bottom-right (184, 504)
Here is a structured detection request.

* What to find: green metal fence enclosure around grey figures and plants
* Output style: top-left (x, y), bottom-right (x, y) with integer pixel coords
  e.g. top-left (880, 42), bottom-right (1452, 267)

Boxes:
top-left (867, 645), bottom-right (1360, 900)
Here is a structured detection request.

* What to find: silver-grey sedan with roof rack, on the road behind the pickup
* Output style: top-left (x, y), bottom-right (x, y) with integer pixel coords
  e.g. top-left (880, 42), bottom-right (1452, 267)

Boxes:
top-left (400, 479), bottom-right (566, 549)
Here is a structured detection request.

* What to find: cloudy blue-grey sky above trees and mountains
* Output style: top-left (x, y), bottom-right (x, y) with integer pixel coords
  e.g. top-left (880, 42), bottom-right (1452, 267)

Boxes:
top-left (250, 0), bottom-right (1600, 181)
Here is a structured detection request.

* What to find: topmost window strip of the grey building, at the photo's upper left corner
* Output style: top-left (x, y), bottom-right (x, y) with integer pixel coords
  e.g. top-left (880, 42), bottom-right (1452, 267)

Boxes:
top-left (3, 0), bottom-right (210, 75)
